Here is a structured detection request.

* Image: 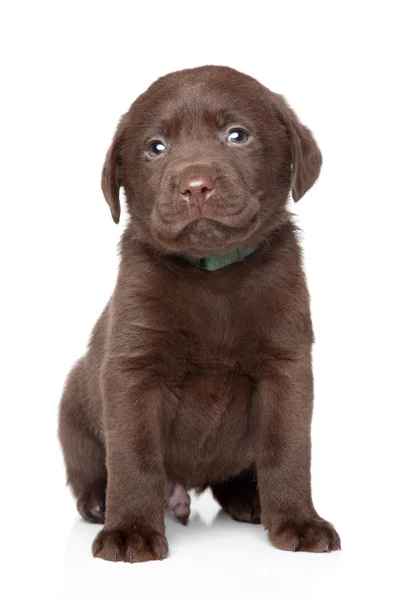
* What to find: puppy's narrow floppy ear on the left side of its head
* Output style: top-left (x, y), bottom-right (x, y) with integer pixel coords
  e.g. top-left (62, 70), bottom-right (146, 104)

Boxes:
top-left (101, 115), bottom-right (126, 223)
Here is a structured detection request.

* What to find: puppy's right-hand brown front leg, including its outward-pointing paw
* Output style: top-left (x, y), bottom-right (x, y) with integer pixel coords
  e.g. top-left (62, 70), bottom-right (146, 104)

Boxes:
top-left (255, 356), bottom-right (340, 552)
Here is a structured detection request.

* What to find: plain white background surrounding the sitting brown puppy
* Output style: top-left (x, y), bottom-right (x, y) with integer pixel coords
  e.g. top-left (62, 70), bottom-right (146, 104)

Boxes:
top-left (0, 0), bottom-right (400, 599)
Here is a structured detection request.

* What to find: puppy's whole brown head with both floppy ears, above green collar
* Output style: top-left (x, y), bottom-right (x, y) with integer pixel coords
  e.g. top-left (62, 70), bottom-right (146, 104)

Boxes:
top-left (102, 66), bottom-right (322, 256)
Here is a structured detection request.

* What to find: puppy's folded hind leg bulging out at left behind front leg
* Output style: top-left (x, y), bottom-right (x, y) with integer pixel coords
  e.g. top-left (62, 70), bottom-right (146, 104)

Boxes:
top-left (58, 359), bottom-right (107, 523)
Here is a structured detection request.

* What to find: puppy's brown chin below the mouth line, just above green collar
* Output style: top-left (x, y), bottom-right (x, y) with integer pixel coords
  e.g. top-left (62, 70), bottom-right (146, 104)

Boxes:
top-left (154, 214), bottom-right (260, 257)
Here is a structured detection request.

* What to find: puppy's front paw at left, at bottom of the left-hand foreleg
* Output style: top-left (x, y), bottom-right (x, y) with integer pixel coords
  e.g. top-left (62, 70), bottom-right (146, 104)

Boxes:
top-left (92, 527), bottom-right (168, 563)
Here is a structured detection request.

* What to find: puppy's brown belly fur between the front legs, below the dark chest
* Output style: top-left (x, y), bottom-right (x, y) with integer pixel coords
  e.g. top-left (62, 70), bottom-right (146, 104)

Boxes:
top-left (164, 372), bottom-right (253, 488)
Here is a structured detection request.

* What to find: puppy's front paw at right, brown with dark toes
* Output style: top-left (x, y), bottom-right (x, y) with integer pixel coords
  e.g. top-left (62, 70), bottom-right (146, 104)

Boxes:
top-left (268, 518), bottom-right (341, 552)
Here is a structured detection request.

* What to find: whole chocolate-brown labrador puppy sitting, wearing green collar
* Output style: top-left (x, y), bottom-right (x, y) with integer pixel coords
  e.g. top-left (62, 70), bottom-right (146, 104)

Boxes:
top-left (59, 66), bottom-right (340, 562)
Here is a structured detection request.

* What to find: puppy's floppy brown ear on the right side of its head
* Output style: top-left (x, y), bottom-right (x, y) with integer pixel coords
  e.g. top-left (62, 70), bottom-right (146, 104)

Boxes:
top-left (273, 94), bottom-right (322, 202)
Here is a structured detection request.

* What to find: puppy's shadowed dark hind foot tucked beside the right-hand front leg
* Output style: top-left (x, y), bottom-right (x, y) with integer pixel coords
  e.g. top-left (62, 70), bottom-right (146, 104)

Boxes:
top-left (211, 468), bottom-right (261, 523)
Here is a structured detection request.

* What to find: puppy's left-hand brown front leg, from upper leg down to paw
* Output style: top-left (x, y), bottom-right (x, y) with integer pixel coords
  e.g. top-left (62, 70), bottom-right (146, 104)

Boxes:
top-left (92, 368), bottom-right (168, 562)
